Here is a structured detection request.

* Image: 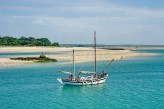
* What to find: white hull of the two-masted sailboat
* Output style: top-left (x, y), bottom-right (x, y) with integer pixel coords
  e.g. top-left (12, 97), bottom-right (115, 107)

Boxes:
top-left (57, 77), bottom-right (107, 86)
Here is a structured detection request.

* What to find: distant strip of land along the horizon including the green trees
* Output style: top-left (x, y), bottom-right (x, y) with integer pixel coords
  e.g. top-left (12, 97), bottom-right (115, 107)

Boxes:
top-left (0, 36), bottom-right (164, 48)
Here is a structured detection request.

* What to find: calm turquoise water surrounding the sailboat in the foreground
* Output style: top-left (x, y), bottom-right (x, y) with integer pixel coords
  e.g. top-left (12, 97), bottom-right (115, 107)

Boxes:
top-left (0, 50), bottom-right (164, 109)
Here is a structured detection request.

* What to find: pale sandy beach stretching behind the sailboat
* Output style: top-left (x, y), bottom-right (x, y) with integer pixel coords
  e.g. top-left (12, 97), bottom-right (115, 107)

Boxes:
top-left (0, 47), bottom-right (157, 67)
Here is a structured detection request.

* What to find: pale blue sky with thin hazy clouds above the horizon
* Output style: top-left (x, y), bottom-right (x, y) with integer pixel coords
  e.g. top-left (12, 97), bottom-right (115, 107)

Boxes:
top-left (0, 0), bottom-right (164, 45)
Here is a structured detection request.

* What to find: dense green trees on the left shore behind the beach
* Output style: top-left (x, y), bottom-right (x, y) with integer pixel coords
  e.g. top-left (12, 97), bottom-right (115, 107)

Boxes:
top-left (0, 36), bottom-right (60, 46)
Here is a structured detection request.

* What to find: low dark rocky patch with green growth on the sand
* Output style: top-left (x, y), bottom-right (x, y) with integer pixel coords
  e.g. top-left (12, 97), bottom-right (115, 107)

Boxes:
top-left (10, 54), bottom-right (57, 63)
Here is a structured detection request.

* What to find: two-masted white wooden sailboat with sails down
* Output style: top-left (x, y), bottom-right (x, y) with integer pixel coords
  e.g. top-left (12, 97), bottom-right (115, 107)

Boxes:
top-left (57, 31), bottom-right (114, 86)
